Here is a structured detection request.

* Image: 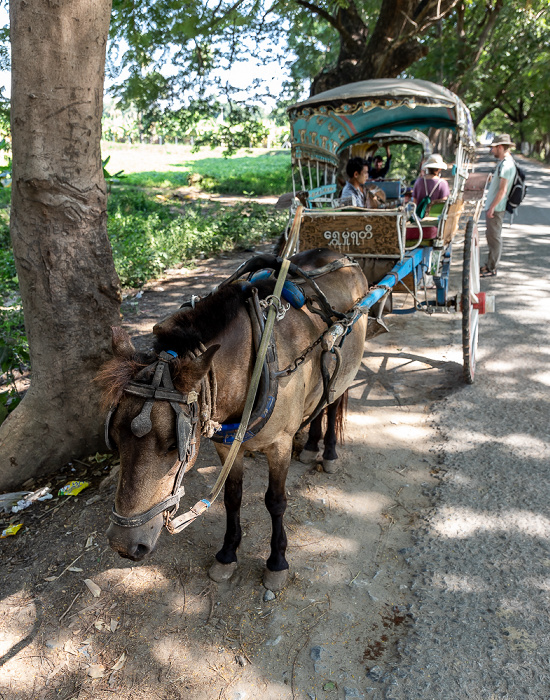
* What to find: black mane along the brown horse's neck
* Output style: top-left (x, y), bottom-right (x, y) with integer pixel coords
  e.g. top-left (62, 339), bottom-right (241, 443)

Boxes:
top-left (153, 280), bottom-right (273, 357)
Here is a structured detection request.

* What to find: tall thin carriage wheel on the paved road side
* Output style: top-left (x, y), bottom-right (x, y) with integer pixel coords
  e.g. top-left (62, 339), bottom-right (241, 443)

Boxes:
top-left (462, 219), bottom-right (480, 384)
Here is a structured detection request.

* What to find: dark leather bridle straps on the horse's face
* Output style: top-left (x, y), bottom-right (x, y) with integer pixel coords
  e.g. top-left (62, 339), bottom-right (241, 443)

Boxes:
top-left (105, 350), bottom-right (202, 530)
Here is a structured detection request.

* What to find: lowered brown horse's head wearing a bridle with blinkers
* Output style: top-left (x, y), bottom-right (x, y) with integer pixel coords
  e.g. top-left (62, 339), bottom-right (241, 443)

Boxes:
top-left (99, 328), bottom-right (219, 561)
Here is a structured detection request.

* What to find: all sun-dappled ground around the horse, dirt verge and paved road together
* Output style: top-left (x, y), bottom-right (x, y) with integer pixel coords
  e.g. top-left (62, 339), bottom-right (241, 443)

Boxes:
top-left (0, 154), bottom-right (550, 700)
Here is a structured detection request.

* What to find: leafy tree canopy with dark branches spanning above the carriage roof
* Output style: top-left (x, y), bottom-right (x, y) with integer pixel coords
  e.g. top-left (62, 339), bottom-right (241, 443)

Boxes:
top-left (102, 0), bottom-right (550, 154)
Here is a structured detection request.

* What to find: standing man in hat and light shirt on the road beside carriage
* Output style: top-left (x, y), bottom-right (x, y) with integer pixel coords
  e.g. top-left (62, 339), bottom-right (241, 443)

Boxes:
top-left (480, 134), bottom-right (516, 277)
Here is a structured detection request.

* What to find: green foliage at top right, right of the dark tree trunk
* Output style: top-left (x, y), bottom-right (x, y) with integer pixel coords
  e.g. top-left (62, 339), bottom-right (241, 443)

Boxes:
top-left (415, 0), bottom-right (550, 141)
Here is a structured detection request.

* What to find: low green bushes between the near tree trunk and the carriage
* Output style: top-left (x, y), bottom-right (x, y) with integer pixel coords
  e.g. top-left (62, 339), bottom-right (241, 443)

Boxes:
top-left (107, 188), bottom-right (286, 287)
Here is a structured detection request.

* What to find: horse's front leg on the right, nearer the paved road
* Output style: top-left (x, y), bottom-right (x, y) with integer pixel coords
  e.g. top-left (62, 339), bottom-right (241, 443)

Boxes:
top-left (263, 436), bottom-right (292, 591)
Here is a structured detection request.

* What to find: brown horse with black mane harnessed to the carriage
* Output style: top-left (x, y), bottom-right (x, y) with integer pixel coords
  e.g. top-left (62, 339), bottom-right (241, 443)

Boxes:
top-left (100, 250), bottom-right (368, 590)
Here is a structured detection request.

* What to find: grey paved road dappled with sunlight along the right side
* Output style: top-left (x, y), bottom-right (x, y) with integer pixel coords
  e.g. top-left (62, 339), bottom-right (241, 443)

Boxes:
top-left (374, 152), bottom-right (550, 700)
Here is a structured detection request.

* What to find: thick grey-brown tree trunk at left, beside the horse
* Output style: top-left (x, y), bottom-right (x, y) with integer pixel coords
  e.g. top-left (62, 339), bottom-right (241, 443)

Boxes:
top-left (0, 0), bottom-right (120, 491)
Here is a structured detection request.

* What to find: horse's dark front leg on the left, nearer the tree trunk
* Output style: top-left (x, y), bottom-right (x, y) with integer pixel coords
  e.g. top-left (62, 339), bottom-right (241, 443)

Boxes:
top-left (208, 445), bottom-right (243, 583)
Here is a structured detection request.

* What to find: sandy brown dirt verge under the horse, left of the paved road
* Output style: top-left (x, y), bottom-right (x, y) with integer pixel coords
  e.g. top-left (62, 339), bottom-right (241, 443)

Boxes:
top-left (0, 232), bottom-right (461, 700)
